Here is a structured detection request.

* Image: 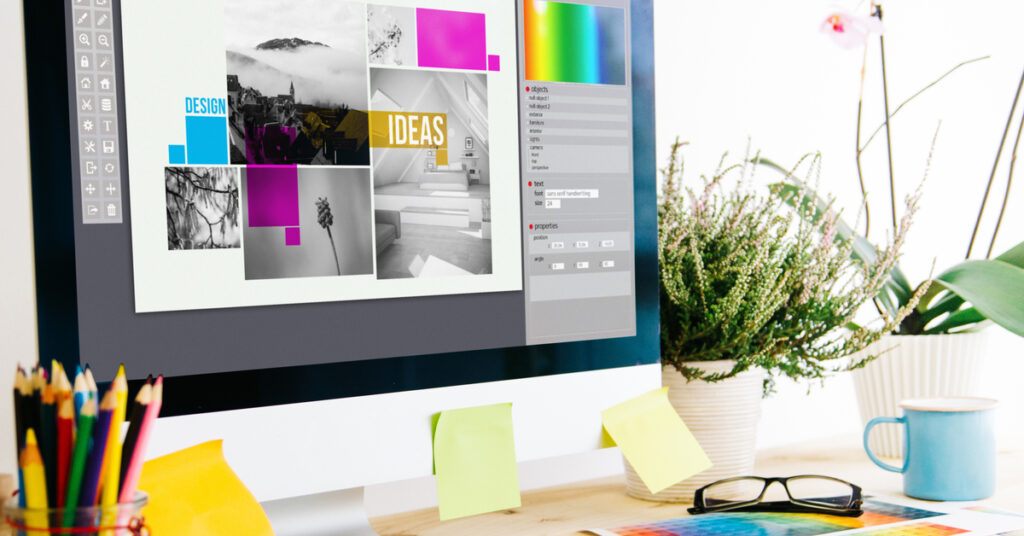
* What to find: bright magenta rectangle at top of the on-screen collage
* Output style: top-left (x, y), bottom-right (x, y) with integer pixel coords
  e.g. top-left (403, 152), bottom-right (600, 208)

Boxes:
top-left (416, 7), bottom-right (487, 71)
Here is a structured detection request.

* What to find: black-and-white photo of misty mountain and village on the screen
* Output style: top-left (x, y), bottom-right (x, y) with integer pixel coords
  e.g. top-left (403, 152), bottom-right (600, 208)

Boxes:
top-left (224, 0), bottom-right (370, 165)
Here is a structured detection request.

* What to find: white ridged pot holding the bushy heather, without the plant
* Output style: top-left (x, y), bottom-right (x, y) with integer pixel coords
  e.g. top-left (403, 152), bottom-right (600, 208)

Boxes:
top-left (626, 361), bottom-right (765, 503)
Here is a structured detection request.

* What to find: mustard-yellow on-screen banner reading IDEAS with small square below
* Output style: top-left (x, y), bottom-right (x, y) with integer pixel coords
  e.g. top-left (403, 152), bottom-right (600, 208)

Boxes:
top-left (370, 112), bottom-right (447, 166)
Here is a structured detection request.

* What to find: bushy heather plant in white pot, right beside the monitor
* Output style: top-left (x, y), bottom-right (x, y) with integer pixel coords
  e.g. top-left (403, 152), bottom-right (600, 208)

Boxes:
top-left (627, 141), bottom-right (920, 502)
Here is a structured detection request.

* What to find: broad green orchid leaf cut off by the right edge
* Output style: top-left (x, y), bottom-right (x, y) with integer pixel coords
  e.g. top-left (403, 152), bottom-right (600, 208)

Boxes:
top-left (935, 260), bottom-right (1024, 337)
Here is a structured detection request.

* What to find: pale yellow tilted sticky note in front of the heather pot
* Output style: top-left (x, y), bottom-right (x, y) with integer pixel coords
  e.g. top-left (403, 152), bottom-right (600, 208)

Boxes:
top-left (601, 387), bottom-right (711, 493)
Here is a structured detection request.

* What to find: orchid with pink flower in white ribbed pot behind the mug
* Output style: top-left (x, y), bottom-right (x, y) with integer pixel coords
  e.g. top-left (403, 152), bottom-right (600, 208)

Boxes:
top-left (759, 1), bottom-right (1024, 457)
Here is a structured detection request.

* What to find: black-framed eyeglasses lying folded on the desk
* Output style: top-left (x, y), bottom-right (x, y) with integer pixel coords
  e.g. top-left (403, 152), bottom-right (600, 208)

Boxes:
top-left (687, 475), bottom-right (863, 518)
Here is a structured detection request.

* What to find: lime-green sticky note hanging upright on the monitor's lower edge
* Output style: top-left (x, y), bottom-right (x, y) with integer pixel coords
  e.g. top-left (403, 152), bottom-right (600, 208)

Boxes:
top-left (434, 404), bottom-right (522, 521)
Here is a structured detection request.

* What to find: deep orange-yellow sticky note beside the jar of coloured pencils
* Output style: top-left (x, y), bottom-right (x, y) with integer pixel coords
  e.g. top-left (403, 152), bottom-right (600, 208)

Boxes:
top-left (138, 441), bottom-right (273, 536)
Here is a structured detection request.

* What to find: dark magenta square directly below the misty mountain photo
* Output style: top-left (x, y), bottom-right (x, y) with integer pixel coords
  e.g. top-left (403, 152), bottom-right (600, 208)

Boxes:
top-left (246, 165), bottom-right (299, 228)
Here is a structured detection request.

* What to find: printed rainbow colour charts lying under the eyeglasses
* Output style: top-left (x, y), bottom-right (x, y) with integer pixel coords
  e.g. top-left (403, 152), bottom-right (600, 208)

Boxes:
top-left (611, 500), bottom-right (946, 536)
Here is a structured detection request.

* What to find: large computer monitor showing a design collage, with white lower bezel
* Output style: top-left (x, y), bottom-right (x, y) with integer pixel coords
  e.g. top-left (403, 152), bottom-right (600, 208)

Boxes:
top-left (25, 0), bottom-right (658, 528)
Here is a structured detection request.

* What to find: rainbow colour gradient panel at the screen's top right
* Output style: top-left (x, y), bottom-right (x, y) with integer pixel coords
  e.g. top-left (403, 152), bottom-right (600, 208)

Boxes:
top-left (523, 0), bottom-right (626, 85)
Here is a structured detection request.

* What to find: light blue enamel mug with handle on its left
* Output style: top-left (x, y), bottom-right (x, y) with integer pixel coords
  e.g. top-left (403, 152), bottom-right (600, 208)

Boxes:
top-left (864, 398), bottom-right (997, 501)
